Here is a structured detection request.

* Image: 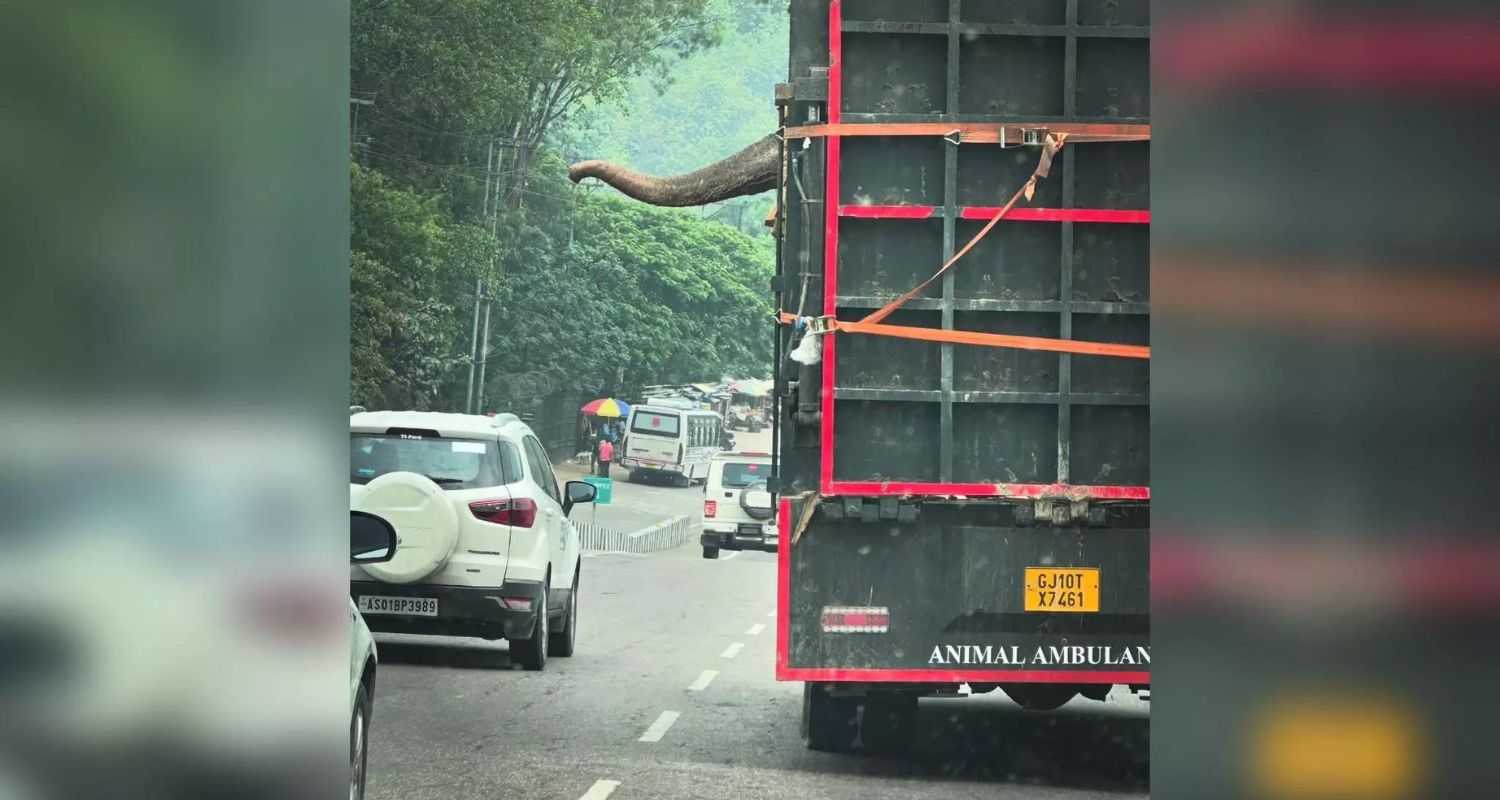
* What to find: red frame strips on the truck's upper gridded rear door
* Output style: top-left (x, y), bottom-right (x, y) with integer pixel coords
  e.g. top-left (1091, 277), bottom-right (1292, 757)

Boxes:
top-left (822, 0), bottom-right (1151, 498)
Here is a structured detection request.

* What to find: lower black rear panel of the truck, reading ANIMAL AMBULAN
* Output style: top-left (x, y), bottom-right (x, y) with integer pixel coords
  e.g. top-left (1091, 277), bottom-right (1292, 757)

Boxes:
top-left (776, 500), bottom-right (1151, 686)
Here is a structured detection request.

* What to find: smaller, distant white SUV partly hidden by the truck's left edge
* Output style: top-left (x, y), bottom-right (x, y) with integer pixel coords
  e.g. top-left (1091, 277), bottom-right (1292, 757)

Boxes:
top-left (699, 453), bottom-right (777, 558)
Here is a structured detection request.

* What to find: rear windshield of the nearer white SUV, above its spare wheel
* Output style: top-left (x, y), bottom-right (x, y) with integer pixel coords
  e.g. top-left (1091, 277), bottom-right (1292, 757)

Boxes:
top-left (350, 434), bottom-right (522, 489)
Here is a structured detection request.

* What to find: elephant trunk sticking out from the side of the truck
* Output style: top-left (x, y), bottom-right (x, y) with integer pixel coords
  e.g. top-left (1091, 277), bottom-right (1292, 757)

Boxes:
top-left (567, 134), bottom-right (782, 207)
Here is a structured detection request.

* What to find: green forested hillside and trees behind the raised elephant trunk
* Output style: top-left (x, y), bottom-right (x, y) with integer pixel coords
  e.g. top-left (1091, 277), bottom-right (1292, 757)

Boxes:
top-left (350, 0), bottom-right (786, 411)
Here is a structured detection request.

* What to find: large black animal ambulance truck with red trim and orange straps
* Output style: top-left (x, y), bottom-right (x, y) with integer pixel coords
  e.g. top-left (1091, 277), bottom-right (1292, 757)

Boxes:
top-left (771, 0), bottom-right (1151, 750)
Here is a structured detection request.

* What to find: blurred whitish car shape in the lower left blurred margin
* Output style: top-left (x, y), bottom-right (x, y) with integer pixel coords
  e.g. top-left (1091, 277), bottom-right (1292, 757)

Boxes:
top-left (0, 414), bottom-right (350, 797)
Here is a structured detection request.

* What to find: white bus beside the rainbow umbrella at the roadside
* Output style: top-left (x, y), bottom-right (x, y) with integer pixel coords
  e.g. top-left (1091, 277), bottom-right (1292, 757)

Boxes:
top-left (617, 401), bottom-right (725, 486)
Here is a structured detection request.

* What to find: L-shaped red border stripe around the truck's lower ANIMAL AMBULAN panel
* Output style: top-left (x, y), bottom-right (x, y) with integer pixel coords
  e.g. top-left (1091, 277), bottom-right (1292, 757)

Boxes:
top-left (776, 498), bottom-right (1151, 686)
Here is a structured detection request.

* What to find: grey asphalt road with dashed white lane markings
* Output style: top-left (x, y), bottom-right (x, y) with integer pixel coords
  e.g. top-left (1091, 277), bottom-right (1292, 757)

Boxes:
top-left (368, 429), bottom-right (1149, 800)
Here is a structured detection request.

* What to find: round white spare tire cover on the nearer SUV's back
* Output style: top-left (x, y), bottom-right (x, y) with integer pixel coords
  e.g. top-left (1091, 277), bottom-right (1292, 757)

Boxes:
top-left (350, 473), bottom-right (459, 584)
